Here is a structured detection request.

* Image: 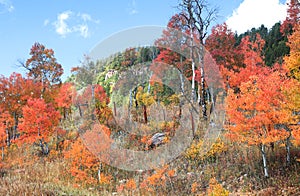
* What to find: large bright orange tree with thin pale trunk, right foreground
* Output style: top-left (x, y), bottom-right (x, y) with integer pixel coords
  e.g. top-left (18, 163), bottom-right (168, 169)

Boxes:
top-left (226, 68), bottom-right (289, 177)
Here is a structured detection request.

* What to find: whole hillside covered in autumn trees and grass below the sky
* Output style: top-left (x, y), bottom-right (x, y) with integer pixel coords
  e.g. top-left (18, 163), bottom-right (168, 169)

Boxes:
top-left (0, 0), bottom-right (300, 195)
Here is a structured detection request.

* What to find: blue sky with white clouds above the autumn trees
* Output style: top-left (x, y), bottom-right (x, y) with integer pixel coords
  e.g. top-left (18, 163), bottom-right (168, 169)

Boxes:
top-left (0, 0), bottom-right (286, 78)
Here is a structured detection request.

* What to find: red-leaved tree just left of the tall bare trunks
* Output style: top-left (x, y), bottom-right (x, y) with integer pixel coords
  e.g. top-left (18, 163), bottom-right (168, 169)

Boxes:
top-left (150, 14), bottom-right (195, 96)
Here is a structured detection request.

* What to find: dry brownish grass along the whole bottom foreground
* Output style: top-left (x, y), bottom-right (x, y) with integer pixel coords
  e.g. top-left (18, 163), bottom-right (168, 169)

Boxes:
top-left (0, 139), bottom-right (300, 195)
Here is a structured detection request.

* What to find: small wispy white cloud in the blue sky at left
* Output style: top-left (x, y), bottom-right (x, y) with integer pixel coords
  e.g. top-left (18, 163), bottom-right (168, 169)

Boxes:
top-left (51, 10), bottom-right (99, 38)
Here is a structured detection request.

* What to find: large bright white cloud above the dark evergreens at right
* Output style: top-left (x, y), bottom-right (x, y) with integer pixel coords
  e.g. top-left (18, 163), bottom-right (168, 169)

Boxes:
top-left (226, 0), bottom-right (288, 34)
